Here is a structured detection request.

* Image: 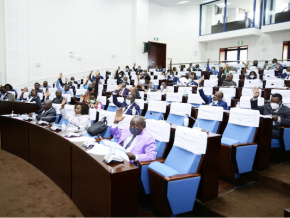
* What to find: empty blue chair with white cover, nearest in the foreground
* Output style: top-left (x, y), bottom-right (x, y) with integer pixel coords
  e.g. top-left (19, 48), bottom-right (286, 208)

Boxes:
top-left (148, 126), bottom-right (207, 216)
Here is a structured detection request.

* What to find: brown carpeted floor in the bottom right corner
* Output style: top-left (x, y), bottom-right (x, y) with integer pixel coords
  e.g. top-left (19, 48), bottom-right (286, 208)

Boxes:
top-left (203, 183), bottom-right (290, 217)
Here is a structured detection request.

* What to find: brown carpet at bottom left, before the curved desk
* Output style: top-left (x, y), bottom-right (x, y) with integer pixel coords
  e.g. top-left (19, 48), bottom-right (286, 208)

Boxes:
top-left (0, 149), bottom-right (83, 217)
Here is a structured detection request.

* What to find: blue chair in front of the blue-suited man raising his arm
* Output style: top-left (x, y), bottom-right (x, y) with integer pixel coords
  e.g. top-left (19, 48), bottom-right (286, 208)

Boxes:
top-left (193, 105), bottom-right (224, 133)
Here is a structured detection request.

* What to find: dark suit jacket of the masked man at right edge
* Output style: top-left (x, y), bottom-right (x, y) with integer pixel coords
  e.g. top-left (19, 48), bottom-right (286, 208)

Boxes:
top-left (251, 99), bottom-right (290, 139)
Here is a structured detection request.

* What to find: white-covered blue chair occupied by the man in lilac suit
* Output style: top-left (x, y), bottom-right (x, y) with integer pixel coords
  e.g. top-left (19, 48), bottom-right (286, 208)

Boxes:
top-left (138, 119), bottom-right (171, 195)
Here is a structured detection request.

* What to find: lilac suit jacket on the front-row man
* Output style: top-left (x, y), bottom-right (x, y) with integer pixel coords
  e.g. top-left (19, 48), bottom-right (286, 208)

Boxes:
top-left (110, 127), bottom-right (157, 162)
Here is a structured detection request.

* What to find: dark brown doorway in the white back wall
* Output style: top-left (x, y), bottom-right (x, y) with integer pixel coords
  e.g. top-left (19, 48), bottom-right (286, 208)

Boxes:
top-left (148, 42), bottom-right (166, 69)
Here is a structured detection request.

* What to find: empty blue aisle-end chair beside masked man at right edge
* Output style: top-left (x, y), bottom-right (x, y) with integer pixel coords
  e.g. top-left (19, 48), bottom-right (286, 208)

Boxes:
top-left (220, 108), bottom-right (260, 180)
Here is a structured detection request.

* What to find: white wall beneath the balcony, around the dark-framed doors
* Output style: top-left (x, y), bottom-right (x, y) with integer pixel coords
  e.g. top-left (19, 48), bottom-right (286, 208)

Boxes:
top-left (204, 30), bottom-right (290, 61)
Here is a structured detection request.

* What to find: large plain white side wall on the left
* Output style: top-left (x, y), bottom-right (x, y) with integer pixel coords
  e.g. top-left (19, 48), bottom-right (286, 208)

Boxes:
top-left (5, 0), bottom-right (135, 85)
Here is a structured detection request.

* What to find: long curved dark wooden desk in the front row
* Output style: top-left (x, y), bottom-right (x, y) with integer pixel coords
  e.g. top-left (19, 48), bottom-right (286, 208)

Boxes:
top-left (1, 117), bottom-right (138, 217)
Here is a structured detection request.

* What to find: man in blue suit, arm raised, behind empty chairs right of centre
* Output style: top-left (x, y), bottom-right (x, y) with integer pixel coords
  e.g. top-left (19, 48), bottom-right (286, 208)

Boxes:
top-left (199, 76), bottom-right (228, 110)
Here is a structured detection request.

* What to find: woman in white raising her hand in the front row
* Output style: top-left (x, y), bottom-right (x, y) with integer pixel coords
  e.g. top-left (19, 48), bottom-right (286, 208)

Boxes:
top-left (60, 98), bottom-right (91, 132)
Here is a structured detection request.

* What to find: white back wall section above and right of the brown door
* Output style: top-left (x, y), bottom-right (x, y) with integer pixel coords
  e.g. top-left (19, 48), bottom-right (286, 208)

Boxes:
top-left (149, 3), bottom-right (206, 64)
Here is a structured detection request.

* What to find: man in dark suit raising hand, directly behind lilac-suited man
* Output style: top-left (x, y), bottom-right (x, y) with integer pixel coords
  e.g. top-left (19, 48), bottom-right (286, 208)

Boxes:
top-left (113, 88), bottom-right (140, 115)
